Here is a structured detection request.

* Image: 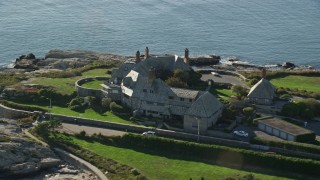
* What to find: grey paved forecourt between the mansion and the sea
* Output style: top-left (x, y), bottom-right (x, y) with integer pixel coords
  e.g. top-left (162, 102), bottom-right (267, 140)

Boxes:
top-left (201, 74), bottom-right (248, 88)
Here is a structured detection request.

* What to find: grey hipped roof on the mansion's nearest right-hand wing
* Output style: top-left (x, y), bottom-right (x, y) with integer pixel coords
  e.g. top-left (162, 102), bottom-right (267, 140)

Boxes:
top-left (186, 91), bottom-right (222, 118)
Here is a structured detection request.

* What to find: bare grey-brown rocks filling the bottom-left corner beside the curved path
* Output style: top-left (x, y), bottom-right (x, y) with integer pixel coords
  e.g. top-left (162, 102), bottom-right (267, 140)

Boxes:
top-left (0, 119), bottom-right (96, 179)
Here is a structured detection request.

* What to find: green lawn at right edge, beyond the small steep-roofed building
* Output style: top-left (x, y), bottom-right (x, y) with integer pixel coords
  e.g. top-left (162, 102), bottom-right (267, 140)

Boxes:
top-left (270, 75), bottom-right (320, 93)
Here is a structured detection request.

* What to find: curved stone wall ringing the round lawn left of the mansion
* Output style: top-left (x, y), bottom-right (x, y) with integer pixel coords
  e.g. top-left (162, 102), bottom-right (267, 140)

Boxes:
top-left (75, 76), bottom-right (109, 98)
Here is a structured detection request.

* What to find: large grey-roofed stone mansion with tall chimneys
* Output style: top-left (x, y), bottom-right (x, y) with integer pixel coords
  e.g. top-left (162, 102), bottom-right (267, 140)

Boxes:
top-left (103, 48), bottom-right (223, 132)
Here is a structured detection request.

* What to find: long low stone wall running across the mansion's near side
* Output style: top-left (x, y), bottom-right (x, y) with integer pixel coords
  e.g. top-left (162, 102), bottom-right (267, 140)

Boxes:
top-left (0, 104), bottom-right (320, 159)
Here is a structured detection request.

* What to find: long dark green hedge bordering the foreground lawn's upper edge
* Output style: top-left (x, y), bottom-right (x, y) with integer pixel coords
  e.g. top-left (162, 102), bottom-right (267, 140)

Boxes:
top-left (84, 134), bottom-right (320, 176)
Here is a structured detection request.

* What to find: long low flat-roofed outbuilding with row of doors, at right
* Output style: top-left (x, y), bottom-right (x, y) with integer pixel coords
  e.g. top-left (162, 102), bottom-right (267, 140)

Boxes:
top-left (258, 118), bottom-right (316, 142)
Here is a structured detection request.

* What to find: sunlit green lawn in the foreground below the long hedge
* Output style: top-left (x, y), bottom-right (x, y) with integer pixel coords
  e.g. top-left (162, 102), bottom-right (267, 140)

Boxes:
top-left (72, 137), bottom-right (285, 180)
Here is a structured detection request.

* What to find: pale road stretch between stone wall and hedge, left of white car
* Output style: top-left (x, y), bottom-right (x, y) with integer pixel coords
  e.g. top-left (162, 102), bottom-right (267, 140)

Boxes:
top-left (62, 123), bottom-right (126, 136)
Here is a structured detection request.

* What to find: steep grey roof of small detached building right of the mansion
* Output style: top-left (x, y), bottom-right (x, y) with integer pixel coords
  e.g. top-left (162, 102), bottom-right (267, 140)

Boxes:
top-left (248, 78), bottom-right (275, 99)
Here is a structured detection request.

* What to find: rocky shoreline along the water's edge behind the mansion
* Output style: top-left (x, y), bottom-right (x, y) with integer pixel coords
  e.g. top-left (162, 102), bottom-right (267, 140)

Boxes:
top-left (0, 50), bottom-right (318, 73)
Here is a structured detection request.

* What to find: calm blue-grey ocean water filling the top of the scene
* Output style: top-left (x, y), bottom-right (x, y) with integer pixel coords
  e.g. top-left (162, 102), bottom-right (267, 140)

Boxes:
top-left (0, 0), bottom-right (320, 68)
